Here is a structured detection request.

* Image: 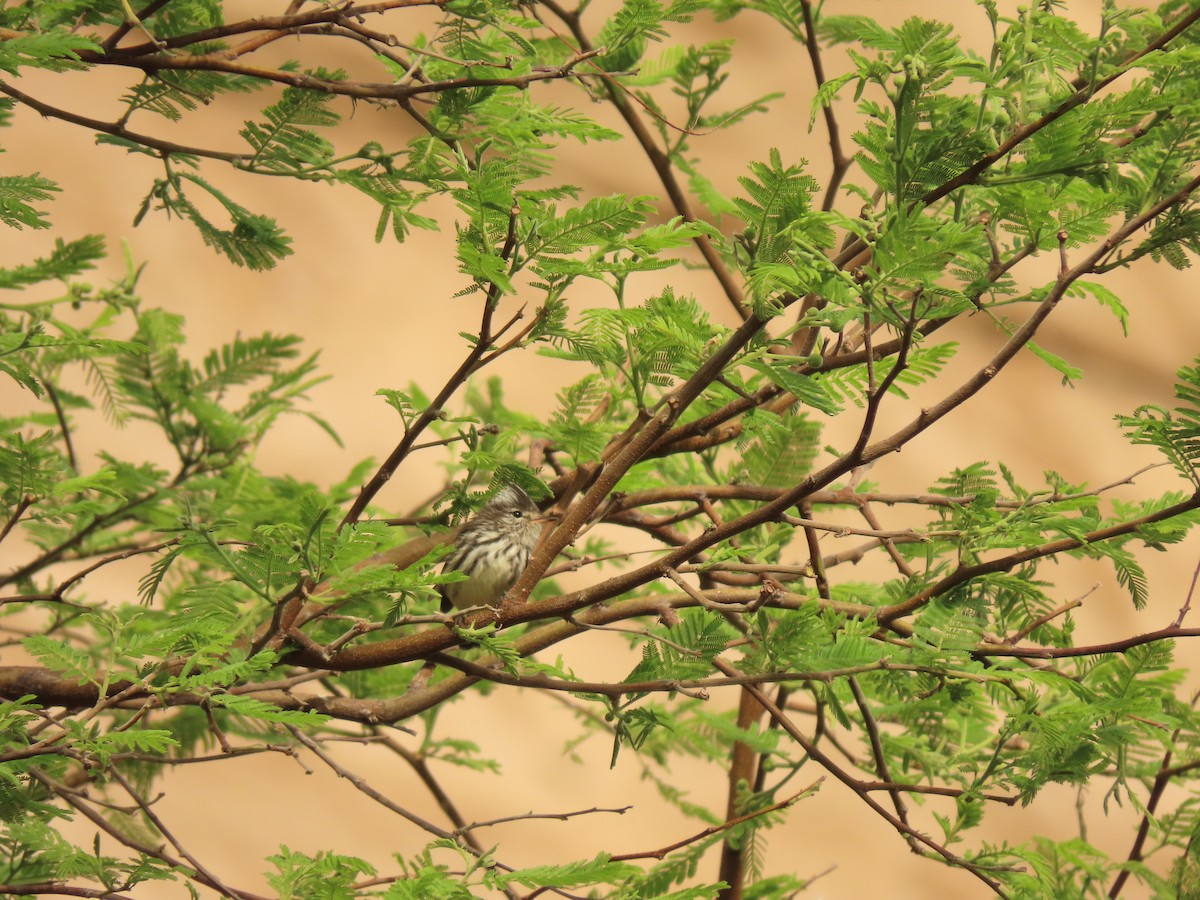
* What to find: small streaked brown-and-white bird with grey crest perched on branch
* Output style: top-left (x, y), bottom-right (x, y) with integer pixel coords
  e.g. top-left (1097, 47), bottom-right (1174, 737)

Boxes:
top-left (438, 485), bottom-right (548, 612)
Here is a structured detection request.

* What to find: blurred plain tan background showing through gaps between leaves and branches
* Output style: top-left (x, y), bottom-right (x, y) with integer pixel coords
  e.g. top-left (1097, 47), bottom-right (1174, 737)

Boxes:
top-left (0, 0), bottom-right (1200, 900)
